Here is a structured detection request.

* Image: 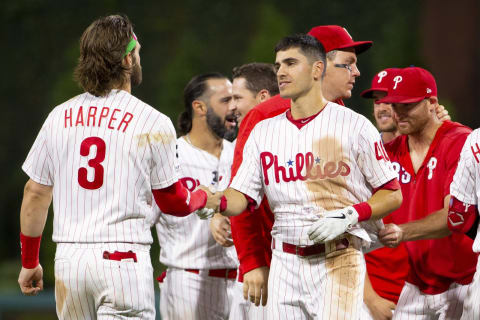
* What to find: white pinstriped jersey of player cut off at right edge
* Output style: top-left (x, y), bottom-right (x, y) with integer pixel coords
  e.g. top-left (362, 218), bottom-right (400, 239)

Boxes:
top-left (450, 129), bottom-right (480, 252)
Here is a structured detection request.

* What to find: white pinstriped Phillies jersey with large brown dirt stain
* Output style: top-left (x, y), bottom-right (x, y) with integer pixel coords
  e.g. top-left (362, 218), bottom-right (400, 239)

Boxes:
top-left (231, 102), bottom-right (397, 245)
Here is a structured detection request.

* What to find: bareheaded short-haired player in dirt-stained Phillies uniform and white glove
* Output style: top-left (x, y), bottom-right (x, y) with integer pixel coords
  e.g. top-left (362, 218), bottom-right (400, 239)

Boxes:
top-left (202, 35), bottom-right (401, 319)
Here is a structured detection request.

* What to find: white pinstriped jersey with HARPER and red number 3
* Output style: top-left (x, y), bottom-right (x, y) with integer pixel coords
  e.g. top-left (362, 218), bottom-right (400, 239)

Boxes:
top-left (22, 90), bottom-right (178, 244)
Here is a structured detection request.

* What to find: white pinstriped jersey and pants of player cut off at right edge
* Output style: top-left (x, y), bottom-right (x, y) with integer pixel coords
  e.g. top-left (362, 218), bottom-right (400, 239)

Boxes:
top-left (450, 129), bottom-right (480, 320)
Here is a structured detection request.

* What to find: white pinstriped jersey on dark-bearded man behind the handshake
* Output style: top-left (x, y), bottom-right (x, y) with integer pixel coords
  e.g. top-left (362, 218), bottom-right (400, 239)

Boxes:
top-left (156, 137), bottom-right (238, 269)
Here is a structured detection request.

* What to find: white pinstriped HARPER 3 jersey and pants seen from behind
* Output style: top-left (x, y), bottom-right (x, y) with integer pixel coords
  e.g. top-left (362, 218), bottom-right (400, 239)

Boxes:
top-left (22, 90), bottom-right (177, 319)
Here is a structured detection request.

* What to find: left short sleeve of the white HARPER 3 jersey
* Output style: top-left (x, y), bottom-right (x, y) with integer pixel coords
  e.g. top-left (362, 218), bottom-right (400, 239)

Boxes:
top-left (22, 114), bottom-right (53, 186)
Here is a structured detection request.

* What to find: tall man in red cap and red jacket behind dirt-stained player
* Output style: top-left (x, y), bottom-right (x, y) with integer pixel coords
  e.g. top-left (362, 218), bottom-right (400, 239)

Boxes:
top-left (227, 25), bottom-right (372, 316)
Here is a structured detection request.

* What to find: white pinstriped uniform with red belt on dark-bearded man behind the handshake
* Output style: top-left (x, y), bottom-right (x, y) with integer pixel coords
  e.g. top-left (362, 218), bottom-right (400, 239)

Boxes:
top-left (156, 137), bottom-right (238, 320)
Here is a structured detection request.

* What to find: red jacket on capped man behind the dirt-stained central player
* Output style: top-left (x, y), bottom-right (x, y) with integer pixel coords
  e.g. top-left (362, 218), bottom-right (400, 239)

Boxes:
top-left (230, 95), bottom-right (343, 281)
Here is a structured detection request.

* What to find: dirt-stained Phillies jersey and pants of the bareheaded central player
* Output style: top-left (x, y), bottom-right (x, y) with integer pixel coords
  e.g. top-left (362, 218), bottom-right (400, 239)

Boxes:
top-left (231, 102), bottom-right (396, 319)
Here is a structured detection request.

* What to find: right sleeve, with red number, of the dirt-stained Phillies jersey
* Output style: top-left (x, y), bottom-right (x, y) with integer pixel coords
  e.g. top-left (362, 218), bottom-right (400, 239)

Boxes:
top-left (357, 118), bottom-right (397, 188)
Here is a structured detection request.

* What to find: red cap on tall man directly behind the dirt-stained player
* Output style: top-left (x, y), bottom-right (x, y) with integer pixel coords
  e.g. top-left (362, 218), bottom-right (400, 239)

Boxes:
top-left (308, 25), bottom-right (373, 54)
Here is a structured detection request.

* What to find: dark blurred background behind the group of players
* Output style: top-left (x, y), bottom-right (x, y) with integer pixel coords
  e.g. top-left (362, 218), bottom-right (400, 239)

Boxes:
top-left (0, 0), bottom-right (480, 319)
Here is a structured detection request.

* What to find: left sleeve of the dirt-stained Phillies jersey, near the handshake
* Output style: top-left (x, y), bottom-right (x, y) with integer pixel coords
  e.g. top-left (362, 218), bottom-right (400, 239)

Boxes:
top-left (230, 129), bottom-right (264, 206)
